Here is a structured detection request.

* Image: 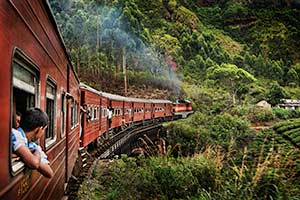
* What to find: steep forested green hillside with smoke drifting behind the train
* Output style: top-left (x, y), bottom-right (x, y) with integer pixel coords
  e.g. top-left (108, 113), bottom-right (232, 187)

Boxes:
top-left (50, 0), bottom-right (300, 102)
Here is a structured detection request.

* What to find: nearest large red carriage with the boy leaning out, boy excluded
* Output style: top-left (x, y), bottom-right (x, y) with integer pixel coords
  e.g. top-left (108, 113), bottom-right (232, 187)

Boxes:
top-left (0, 0), bottom-right (80, 199)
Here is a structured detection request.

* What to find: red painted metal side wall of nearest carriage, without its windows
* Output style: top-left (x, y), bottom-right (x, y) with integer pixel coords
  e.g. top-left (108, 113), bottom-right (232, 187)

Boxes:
top-left (0, 0), bottom-right (79, 199)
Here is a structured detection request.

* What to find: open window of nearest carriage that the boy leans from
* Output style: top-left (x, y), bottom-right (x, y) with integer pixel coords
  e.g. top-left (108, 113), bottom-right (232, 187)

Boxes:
top-left (11, 50), bottom-right (39, 175)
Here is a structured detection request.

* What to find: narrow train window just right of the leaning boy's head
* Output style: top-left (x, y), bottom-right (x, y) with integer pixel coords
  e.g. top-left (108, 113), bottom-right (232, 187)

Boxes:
top-left (45, 79), bottom-right (56, 148)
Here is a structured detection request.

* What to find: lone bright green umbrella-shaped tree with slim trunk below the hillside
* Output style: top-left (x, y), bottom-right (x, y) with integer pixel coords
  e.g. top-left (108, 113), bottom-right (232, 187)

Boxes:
top-left (207, 64), bottom-right (256, 105)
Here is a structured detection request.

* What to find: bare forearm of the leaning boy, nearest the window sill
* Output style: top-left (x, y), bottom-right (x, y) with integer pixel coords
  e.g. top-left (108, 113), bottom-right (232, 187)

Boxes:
top-left (16, 146), bottom-right (41, 169)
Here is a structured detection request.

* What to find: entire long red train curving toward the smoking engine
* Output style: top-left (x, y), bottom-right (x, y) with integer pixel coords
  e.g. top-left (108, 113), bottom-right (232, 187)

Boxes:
top-left (0, 0), bottom-right (191, 199)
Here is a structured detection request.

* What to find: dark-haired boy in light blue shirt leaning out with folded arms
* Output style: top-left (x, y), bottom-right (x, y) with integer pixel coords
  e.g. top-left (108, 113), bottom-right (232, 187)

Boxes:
top-left (12, 108), bottom-right (53, 178)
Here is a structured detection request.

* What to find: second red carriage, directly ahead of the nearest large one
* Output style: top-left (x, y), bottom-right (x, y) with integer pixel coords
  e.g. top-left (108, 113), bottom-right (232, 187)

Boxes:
top-left (80, 83), bottom-right (101, 147)
